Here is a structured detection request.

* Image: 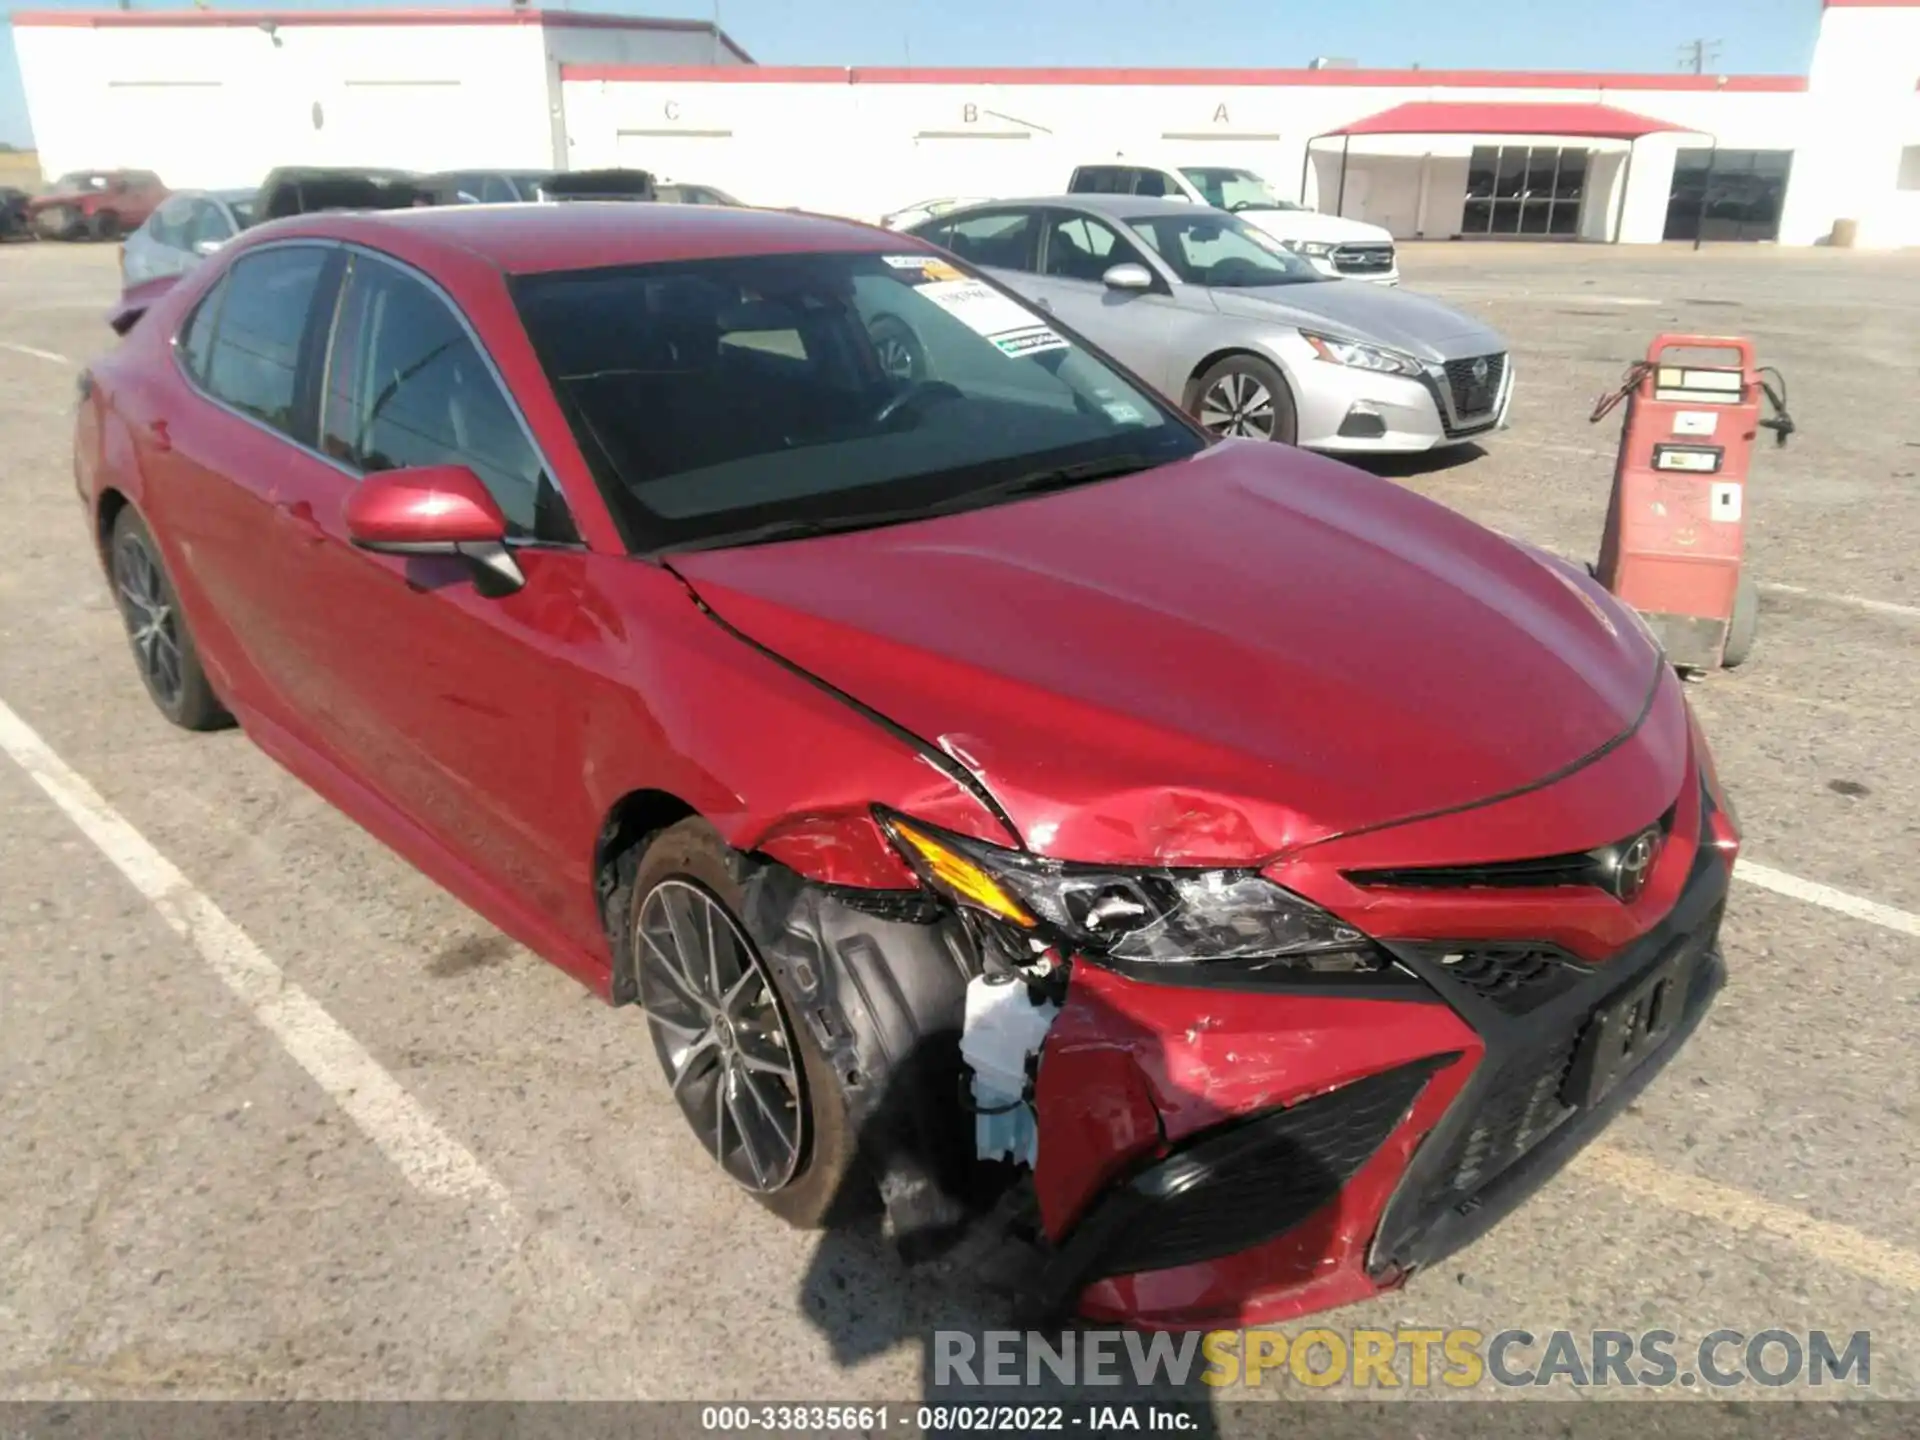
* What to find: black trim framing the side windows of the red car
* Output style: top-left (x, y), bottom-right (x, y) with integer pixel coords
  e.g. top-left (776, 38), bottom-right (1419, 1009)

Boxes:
top-left (167, 236), bottom-right (591, 551)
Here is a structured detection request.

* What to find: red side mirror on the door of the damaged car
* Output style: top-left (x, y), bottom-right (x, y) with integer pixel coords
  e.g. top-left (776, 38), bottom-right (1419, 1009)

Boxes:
top-left (346, 465), bottom-right (526, 589)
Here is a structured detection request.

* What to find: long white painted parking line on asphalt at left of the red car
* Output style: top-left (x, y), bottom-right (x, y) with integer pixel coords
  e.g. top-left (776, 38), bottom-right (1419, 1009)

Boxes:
top-left (0, 703), bottom-right (511, 1219)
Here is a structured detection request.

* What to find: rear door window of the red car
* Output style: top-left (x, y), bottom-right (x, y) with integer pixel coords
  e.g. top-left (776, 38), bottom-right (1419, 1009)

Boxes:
top-left (199, 246), bottom-right (330, 444)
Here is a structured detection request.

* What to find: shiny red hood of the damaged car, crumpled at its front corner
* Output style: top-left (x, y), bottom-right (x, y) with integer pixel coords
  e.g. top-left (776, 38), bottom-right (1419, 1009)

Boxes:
top-left (674, 442), bottom-right (1661, 864)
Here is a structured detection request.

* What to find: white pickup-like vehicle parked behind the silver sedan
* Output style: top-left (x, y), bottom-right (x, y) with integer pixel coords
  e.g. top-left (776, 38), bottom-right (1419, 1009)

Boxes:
top-left (1068, 161), bottom-right (1400, 284)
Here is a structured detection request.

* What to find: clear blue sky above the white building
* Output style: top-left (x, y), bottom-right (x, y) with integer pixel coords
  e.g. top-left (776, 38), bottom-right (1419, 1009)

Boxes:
top-left (0, 0), bottom-right (1820, 144)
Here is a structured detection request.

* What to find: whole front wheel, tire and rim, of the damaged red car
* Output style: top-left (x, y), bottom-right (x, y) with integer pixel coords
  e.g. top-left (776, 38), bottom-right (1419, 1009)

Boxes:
top-left (626, 818), bottom-right (856, 1229)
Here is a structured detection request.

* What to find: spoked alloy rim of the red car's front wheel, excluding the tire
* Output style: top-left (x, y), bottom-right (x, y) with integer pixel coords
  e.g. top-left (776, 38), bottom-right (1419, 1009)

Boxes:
top-left (636, 879), bottom-right (806, 1194)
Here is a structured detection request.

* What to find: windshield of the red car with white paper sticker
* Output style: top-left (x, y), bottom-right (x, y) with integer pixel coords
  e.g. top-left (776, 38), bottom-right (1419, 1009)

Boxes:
top-left (513, 253), bottom-right (1206, 553)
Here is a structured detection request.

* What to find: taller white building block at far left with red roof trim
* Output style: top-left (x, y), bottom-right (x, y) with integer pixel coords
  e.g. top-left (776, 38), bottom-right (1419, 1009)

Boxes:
top-left (13, 4), bottom-right (753, 188)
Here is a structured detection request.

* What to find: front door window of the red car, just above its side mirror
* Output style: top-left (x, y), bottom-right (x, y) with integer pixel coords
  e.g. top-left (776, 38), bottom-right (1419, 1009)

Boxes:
top-left (321, 255), bottom-right (576, 543)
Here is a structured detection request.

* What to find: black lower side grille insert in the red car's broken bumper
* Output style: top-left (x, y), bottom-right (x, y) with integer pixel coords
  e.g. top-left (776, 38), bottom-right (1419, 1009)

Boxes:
top-left (1083, 1054), bottom-right (1455, 1283)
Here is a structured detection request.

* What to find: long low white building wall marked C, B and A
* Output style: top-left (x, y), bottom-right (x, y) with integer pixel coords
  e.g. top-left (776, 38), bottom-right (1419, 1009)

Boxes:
top-left (563, 67), bottom-right (1805, 242)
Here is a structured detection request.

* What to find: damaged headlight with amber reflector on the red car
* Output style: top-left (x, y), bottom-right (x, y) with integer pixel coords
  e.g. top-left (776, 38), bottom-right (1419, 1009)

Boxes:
top-left (876, 810), bottom-right (1392, 975)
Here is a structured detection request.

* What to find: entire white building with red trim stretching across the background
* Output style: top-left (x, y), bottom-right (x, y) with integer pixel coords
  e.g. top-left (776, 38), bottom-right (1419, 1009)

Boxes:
top-left (13, 0), bottom-right (1920, 246)
